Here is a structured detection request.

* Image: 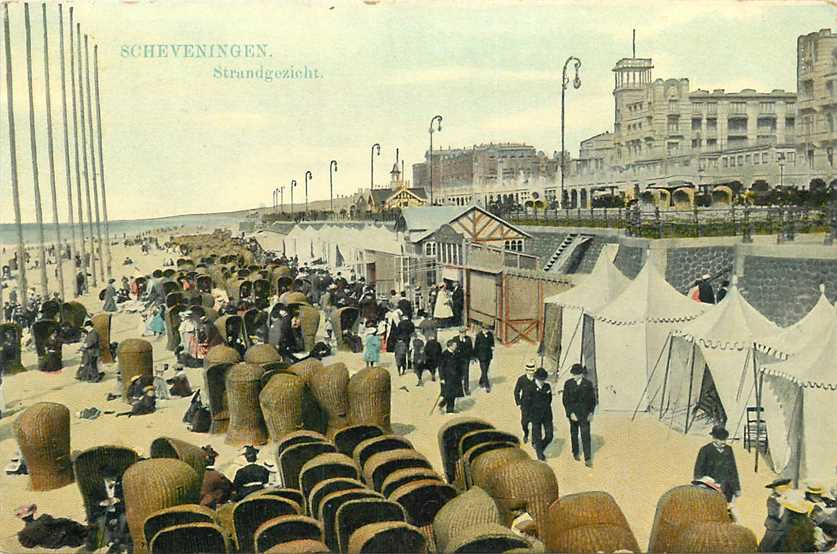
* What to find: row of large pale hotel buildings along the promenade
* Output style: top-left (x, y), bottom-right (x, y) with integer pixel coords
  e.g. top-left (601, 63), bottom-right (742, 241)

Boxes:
top-left (406, 29), bottom-right (837, 207)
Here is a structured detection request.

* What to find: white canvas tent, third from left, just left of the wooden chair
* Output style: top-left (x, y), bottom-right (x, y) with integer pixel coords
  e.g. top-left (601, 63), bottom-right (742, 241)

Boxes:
top-left (649, 277), bottom-right (779, 436)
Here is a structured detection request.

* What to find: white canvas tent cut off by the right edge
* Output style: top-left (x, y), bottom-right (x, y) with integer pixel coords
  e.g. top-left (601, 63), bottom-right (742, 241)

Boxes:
top-left (760, 298), bottom-right (837, 481)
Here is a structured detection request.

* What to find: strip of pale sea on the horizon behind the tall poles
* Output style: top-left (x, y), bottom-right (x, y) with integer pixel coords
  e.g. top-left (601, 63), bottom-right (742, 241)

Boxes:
top-left (0, 213), bottom-right (244, 248)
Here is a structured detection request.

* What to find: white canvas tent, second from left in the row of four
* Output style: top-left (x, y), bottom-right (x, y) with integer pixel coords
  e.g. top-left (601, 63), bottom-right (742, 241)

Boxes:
top-left (582, 259), bottom-right (707, 411)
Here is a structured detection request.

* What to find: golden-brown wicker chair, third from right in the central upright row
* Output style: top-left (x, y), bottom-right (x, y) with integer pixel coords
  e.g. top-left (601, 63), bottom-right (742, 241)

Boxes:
top-left (259, 373), bottom-right (305, 442)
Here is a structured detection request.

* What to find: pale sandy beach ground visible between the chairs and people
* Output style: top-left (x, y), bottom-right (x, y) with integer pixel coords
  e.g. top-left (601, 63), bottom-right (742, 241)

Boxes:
top-left (0, 234), bottom-right (774, 552)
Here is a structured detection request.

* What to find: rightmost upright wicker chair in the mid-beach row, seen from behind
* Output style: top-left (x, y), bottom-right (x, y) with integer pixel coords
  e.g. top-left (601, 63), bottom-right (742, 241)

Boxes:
top-left (348, 367), bottom-right (392, 433)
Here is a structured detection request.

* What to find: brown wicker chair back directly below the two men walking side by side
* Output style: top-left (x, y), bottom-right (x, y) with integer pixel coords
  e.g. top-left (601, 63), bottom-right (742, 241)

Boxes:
top-left (480, 460), bottom-right (558, 537)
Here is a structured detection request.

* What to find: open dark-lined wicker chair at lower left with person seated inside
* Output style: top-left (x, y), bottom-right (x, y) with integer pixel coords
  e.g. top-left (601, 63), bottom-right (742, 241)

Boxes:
top-left (73, 446), bottom-right (139, 521)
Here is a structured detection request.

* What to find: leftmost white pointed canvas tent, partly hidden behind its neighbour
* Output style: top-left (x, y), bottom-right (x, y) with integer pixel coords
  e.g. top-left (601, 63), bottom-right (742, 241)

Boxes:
top-left (544, 245), bottom-right (630, 375)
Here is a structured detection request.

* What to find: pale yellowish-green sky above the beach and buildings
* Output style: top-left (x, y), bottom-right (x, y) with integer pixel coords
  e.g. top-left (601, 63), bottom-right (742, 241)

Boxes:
top-left (0, 0), bottom-right (837, 223)
